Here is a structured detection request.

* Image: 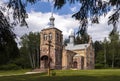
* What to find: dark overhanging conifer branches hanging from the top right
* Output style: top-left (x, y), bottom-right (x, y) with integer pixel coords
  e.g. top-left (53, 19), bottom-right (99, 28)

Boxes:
top-left (54, 0), bottom-right (120, 32)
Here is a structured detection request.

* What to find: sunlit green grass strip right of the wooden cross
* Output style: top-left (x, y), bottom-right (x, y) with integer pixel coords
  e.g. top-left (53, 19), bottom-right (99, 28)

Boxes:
top-left (56, 69), bottom-right (120, 76)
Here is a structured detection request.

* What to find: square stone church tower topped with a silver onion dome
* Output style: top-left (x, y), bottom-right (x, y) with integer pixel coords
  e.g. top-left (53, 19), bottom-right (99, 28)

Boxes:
top-left (40, 15), bottom-right (63, 69)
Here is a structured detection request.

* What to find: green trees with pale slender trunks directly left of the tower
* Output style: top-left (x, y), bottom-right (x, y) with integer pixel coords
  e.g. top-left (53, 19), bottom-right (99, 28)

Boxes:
top-left (20, 32), bottom-right (40, 69)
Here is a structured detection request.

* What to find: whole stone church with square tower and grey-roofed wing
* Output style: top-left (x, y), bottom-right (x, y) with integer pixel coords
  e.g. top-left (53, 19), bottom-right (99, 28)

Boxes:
top-left (40, 15), bottom-right (94, 70)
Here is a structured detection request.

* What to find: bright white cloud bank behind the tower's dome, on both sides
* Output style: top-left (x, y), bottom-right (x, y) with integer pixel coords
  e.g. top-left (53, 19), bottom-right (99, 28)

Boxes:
top-left (14, 11), bottom-right (79, 37)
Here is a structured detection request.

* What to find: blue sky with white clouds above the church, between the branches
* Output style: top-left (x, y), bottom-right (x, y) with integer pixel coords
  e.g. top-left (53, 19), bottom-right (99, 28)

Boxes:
top-left (0, 0), bottom-right (120, 41)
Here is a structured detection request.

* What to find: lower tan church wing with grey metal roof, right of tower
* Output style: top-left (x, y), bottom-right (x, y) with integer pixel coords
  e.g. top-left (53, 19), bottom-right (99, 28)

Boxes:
top-left (62, 34), bottom-right (94, 69)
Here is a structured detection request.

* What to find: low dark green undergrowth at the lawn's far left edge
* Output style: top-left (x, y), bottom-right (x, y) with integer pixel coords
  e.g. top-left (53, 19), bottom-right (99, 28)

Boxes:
top-left (0, 64), bottom-right (21, 70)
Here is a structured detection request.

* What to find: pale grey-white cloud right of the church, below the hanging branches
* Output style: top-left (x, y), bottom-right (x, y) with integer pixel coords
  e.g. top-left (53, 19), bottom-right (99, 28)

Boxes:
top-left (88, 11), bottom-right (120, 41)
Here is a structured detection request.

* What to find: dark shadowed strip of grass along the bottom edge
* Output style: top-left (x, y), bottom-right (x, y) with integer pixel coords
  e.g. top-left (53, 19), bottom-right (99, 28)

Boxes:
top-left (0, 73), bottom-right (120, 81)
